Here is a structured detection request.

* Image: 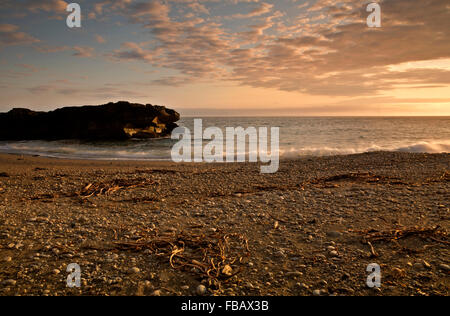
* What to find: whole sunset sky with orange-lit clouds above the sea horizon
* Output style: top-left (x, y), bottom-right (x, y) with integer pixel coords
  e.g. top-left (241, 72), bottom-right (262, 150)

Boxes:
top-left (0, 0), bottom-right (450, 116)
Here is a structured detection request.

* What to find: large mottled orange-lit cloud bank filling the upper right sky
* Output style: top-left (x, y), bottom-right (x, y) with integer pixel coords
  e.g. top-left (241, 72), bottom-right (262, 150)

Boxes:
top-left (96, 0), bottom-right (450, 96)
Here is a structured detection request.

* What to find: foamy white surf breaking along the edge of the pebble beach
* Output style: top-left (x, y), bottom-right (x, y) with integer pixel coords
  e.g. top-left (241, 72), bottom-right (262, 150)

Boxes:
top-left (0, 141), bottom-right (450, 161)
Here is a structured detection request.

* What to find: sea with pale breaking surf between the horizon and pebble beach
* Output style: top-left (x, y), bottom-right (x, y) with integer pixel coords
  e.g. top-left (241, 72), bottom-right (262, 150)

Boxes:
top-left (0, 117), bottom-right (450, 161)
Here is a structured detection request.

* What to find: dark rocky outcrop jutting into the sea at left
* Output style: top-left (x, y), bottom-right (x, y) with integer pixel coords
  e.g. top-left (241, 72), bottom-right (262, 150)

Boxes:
top-left (0, 101), bottom-right (180, 140)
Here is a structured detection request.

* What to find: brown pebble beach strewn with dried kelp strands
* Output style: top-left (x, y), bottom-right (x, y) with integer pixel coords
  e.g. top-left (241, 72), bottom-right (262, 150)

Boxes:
top-left (0, 152), bottom-right (450, 296)
